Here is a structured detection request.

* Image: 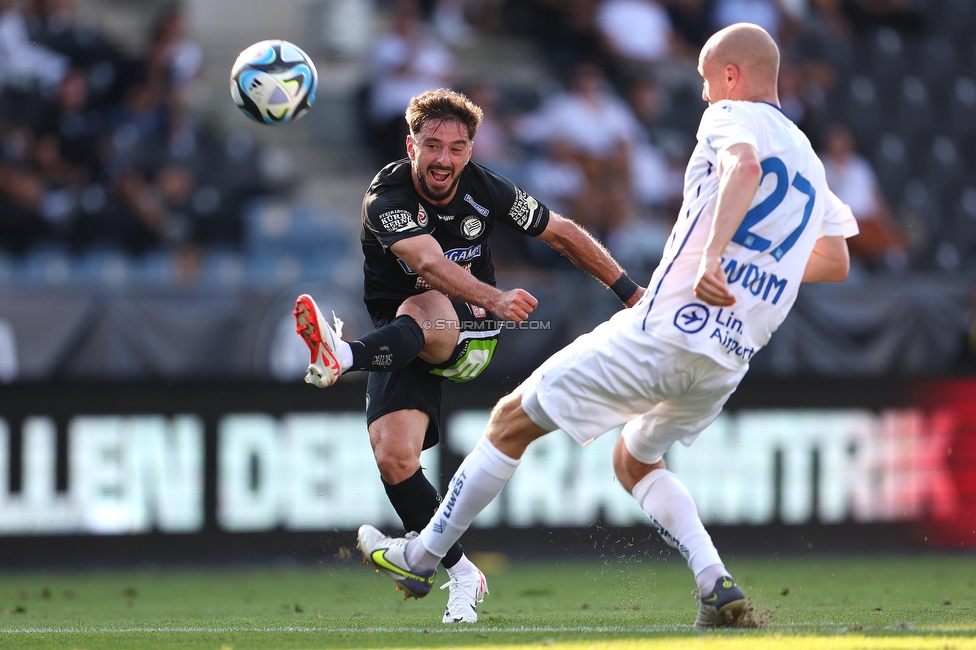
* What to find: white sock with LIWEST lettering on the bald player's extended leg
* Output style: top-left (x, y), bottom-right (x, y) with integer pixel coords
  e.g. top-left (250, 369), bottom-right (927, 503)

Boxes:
top-left (407, 436), bottom-right (519, 568)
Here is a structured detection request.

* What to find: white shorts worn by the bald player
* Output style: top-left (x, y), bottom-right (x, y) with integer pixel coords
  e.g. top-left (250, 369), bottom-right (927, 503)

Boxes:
top-left (522, 309), bottom-right (749, 464)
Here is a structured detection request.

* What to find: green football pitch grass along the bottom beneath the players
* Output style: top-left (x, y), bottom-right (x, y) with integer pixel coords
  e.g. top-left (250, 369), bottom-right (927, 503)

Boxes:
top-left (0, 553), bottom-right (976, 650)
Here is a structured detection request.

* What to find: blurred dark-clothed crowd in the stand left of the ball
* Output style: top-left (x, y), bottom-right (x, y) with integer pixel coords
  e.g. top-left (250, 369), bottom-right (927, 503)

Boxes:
top-left (0, 0), bottom-right (281, 264)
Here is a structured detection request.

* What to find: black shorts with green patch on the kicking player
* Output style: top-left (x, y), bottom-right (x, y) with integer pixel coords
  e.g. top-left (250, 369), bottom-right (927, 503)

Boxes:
top-left (366, 300), bottom-right (500, 449)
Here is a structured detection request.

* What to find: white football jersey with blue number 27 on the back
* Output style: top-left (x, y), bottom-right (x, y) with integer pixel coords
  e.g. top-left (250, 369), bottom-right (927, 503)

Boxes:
top-left (640, 101), bottom-right (857, 369)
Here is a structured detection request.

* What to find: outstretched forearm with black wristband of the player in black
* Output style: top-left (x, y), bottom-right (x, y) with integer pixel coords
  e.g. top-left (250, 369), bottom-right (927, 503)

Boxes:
top-left (539, 212), bottom-right (644, 307)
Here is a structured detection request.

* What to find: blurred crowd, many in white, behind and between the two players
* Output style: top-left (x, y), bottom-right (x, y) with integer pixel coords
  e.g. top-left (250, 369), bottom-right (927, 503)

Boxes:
top-left (362, 0), bottom-right (944, 271)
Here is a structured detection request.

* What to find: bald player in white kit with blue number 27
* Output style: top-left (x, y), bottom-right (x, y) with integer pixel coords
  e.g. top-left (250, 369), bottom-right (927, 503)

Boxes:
top-left (358, 23), bottom-right (857, 627)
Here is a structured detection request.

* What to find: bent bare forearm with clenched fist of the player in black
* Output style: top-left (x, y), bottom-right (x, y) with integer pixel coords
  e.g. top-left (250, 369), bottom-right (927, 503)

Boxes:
top-left (390, 235), bottom-right (539, 323)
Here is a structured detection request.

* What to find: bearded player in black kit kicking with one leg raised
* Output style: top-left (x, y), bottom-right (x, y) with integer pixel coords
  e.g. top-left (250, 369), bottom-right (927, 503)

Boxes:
top-left (295, 89), bottom-right (643, 623)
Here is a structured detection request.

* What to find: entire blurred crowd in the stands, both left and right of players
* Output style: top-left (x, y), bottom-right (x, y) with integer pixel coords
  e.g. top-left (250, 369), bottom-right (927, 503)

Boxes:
top-left (0, 0), bottom-right (976, 280)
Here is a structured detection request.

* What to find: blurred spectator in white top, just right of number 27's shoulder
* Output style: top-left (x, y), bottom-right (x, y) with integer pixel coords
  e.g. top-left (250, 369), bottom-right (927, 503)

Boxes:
top-left (822, 123), bottom-right (907, 269)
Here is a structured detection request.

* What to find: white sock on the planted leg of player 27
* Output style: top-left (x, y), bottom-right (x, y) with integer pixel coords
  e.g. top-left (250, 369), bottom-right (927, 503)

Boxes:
top-left (633, 469), bottom-right (728, 594)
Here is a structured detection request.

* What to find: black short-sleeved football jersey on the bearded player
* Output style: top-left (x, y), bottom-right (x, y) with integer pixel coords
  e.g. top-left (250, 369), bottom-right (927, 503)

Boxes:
top-left (361, 158), bottom-right (549, 326)
